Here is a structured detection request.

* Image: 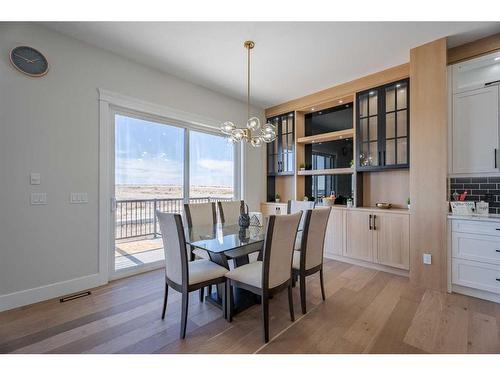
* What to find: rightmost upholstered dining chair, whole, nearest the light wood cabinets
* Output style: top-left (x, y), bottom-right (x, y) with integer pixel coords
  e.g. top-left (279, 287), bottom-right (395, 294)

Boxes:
top-left (292, 207), bottom-right (331, 314)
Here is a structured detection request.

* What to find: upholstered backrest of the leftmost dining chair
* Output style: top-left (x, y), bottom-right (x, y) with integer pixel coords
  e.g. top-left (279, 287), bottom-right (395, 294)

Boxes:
top-left (156, 211), bottom-right (189, 285)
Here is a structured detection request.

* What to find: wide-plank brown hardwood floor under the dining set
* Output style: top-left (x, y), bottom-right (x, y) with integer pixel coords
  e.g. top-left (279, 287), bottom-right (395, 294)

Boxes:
top-left (0, 261), bottom-right (500, 353)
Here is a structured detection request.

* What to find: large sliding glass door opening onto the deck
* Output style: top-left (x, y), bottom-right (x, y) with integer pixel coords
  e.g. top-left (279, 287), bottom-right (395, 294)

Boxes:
top-left (113, 111), bottom-right (239, 277)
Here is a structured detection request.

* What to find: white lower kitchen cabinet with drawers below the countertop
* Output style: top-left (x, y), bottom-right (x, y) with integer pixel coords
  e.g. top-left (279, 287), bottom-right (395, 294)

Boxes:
top-left (451, 219), bottom-right (500, 301)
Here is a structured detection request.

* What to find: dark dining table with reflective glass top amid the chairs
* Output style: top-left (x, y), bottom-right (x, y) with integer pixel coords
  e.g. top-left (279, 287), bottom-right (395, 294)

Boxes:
top-left (185, 223), bottom-right (265, 314)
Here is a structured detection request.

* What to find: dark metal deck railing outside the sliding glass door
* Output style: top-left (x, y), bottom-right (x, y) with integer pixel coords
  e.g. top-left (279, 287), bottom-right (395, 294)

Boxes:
top-left (115, 197), bottom-right (232, 240)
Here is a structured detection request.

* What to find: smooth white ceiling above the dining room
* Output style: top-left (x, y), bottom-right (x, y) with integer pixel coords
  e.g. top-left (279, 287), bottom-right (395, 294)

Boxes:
top-left (44, 22), bottom-right (500, 107)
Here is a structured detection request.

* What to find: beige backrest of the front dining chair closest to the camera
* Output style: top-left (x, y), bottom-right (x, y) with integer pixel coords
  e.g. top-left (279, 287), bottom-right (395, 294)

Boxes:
top-left (262, 212), bottom-right (302, 288)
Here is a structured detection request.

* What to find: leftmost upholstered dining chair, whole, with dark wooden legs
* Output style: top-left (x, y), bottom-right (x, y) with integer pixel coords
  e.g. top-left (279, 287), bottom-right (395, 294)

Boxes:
top-left (156, 211), bottom-right (227, 339)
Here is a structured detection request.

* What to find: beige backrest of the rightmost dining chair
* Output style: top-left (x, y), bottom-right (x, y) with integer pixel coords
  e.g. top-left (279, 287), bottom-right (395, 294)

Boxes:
top-left (300, 207), bottom-right (331, 270)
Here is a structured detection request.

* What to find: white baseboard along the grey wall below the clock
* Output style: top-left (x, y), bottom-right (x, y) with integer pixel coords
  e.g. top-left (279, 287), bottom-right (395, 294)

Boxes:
top-left (0, 273), bottom-right (107, 311)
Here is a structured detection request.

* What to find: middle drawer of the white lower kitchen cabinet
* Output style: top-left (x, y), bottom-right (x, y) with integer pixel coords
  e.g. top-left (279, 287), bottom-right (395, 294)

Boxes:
top-left (452, 232), bottom-right (500, 265)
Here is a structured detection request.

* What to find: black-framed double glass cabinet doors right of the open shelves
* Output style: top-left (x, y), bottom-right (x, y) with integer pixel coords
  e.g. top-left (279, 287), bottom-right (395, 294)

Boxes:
top-left (356, 79), bottom-right (410, 171)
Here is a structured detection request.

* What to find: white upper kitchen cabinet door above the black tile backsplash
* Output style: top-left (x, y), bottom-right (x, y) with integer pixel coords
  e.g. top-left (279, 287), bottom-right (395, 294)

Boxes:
top-left (451, 85), bottom-right (500, 174)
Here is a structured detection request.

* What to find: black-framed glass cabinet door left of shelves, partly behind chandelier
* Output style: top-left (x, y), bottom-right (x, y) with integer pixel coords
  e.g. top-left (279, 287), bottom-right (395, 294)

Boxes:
top-left (267, 112), bottom-right (295, 176)
